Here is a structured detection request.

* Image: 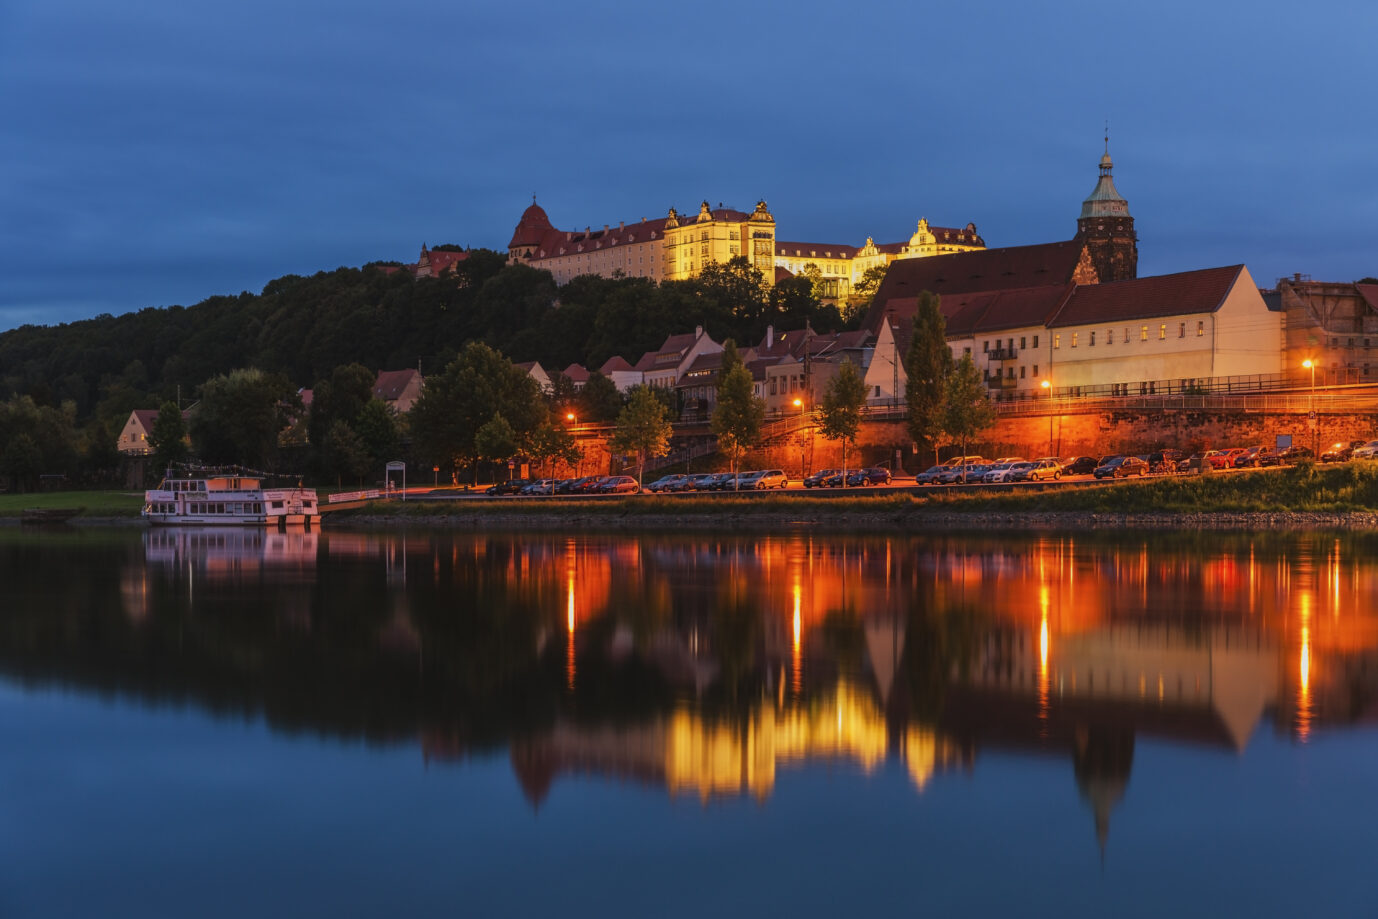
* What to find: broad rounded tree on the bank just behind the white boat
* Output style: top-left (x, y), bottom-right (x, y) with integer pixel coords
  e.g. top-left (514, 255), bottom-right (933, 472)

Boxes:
top-left (190, 368), bottom-right (302, 467)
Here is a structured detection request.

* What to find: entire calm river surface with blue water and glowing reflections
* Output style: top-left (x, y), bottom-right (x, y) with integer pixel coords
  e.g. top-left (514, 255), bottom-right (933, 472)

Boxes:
top-left (0, 529), bottom-right (1378, 918)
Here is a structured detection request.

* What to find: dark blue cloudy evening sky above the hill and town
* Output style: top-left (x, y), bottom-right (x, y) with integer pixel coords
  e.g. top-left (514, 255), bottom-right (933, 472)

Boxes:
top-left (0, 0), bottom-right (1378, 329)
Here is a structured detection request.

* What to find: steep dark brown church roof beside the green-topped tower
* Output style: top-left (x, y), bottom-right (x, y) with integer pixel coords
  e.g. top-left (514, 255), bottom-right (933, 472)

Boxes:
top-left (861, 240), bottom-right (1083, 332)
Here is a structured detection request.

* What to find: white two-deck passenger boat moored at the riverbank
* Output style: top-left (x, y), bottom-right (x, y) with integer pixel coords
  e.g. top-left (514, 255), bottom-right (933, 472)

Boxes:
top-left (143, 470), bottom-right (321, 526)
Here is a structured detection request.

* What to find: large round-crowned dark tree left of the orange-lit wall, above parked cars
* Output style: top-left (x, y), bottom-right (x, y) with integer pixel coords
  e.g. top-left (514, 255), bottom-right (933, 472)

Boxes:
top-left (411, 342), bottom-right (548, 482)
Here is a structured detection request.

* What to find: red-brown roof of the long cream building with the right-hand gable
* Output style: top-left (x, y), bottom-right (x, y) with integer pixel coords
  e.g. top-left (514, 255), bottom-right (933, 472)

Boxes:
top-left (1047, 265), bottom-right (1244, 328)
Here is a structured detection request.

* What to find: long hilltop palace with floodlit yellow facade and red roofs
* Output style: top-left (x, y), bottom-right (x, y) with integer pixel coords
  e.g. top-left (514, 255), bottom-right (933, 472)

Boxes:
top-left (507, 201), bottom-right (985, 299)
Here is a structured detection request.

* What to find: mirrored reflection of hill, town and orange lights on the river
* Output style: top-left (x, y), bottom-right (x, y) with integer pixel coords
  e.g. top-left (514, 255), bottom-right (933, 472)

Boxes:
top-left (0, 530), bottom-right (1378, 845)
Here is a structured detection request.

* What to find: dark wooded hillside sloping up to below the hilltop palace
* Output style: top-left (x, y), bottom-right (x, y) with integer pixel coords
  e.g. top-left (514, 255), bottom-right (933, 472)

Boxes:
top-left (0, 249), bottom-right (843, 479)
